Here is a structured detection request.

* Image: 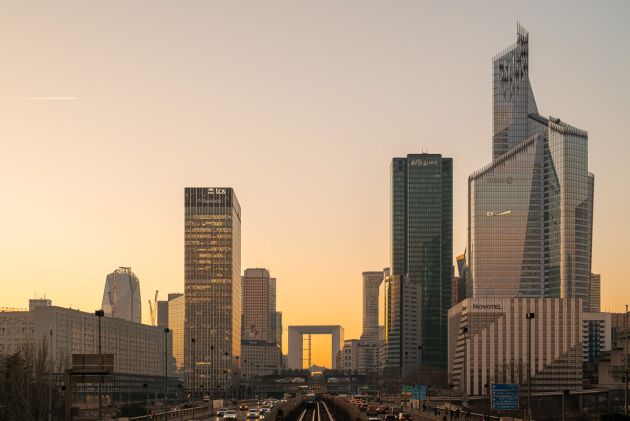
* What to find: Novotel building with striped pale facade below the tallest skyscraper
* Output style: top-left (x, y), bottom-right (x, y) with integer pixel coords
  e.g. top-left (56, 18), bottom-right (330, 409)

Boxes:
top-left (448, 298), bottom-right (583, 396)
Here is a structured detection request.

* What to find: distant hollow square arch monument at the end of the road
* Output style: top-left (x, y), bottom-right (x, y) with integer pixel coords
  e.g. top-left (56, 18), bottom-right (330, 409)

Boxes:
top-left (287, 325), bottom-right (343, 370)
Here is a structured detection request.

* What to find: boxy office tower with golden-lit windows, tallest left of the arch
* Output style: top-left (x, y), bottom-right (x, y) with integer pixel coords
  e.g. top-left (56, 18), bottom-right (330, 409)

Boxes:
top-left (184, 187), bottom-right (241, 394)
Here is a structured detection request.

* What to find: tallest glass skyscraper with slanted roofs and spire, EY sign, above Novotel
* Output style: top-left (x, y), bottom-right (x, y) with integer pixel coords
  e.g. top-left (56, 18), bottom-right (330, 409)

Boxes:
top-left (468, 25), bottom-right (594, 309)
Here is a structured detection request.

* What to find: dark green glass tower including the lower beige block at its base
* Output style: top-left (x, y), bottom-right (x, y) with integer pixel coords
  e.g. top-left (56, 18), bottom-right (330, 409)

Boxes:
top-left (386, 153), bottom-right (453, 374)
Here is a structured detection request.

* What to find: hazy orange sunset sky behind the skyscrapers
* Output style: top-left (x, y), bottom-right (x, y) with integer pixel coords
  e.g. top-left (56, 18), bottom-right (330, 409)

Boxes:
top-left (0, 0), bottom-right (630, 364)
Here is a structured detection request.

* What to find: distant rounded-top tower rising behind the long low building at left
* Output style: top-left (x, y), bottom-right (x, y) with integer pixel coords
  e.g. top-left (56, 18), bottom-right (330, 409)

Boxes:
top-left (101, 267), bottom-right (142, 323)
